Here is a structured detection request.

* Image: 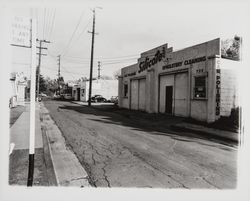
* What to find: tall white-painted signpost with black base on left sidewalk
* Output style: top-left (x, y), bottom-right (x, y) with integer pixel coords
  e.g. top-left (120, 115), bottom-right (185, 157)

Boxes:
top-left (27, 19), bottom-right (37, 186)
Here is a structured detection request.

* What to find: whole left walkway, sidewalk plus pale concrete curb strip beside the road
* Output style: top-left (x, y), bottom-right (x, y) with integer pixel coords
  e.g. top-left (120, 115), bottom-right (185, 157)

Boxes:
top-left (9, 103), bottom-right (90, 187)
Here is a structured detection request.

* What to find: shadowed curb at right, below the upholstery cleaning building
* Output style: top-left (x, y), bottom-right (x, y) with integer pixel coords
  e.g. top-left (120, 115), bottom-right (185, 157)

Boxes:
top-left (170, 125), bottom-right (239, 144)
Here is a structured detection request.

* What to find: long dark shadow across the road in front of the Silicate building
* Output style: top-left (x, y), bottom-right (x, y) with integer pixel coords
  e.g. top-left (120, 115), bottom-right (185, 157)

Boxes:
top-left (50, 102), bottom-right (234, 148)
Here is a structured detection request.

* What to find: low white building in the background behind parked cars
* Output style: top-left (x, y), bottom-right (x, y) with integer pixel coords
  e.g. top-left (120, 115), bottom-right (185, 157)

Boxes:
top-left (72, 78), bottom-right (118, 102)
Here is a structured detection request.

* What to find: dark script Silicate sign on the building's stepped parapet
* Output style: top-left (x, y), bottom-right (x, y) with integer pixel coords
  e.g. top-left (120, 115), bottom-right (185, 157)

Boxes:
top-left (138, 47), bottom-right (165, 73)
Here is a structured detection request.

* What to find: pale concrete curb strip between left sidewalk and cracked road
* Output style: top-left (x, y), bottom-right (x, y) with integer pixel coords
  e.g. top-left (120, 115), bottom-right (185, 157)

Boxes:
top-left (41, 104), bottom-right (91, 187)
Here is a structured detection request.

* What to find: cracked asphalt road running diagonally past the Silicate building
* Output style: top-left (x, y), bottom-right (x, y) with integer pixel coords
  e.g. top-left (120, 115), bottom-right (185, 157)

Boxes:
top-left (44, 101), bottom-right (237, 189)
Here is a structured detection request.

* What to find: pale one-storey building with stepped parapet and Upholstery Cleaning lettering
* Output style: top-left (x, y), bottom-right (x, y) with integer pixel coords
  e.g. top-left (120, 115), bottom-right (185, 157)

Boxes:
top-left (118, 38), bottom-right (241, 122)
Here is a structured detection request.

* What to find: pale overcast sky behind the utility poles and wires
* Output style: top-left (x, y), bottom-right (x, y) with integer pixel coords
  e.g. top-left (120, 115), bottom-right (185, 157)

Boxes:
top-left (11, 0), bottom-right (249, 81)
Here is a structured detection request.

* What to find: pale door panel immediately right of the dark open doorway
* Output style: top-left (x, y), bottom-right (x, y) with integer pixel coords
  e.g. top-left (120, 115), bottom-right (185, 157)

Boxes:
top-left (174, 73), bottom-right (188, 117)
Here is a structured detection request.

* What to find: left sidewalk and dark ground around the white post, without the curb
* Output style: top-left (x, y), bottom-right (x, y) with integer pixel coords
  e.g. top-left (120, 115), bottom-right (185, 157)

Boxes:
top-left (9, 103), bottom-right (48, 186)
